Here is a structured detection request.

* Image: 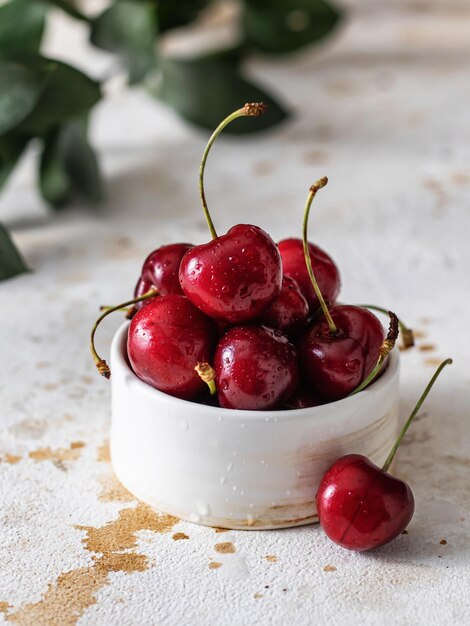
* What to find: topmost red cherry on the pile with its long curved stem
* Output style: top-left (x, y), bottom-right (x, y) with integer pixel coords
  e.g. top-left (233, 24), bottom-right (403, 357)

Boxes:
top-left (179, 103), bottom-right (282, 324)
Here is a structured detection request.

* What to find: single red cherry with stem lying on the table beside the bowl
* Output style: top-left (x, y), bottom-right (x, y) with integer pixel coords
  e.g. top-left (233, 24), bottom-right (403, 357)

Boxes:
top-left (316, 359), bottom-right (452, 551)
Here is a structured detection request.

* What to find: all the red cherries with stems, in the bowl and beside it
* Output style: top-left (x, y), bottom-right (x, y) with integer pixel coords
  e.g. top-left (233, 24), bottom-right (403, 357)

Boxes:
top-left (91, 103), bottom-right (450, 550)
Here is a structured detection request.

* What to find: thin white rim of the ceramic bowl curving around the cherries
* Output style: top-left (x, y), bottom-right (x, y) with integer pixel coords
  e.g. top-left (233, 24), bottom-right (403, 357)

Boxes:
top-left (110, 321), bottom-right (399, 422)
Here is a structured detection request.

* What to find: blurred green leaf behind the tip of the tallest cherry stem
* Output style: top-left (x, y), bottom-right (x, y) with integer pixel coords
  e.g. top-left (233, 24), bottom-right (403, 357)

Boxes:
top-left (151, 49), bottom-right (287, 134)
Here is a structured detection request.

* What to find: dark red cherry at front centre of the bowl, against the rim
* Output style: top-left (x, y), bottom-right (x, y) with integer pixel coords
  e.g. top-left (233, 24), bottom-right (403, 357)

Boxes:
top-left (214, 326), bottom-right (299, 411)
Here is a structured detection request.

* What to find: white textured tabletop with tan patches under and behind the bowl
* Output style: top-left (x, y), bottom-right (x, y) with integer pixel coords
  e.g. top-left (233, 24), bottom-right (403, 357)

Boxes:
top-left (0, 0), bottom-right (470, 626)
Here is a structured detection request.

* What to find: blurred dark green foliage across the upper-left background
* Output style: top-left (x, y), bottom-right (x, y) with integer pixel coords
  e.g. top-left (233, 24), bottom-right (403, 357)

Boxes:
top-left (0, 0), bottom-right (340, 279)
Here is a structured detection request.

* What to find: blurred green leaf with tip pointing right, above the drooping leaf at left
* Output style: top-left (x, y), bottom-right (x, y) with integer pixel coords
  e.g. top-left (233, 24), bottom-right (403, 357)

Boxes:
top-left (17, 56), bottom-right (101, 135)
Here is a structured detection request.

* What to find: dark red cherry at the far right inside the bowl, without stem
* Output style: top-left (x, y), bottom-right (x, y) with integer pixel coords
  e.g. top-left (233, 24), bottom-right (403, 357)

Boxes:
top-left (299, 305), bottom-right (385, 401)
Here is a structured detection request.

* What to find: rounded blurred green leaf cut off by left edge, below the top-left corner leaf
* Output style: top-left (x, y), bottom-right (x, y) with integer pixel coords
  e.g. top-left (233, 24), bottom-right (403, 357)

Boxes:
top-left (0, 60), bottom-right (44, 136)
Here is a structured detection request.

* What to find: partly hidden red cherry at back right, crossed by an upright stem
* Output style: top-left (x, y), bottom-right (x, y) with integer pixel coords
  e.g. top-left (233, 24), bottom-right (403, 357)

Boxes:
top-left (278, 239), bottom-right (341, 313)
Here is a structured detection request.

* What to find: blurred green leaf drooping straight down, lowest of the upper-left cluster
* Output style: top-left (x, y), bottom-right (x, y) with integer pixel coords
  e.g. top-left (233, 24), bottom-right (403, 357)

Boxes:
top-left (39, 120), bottom-right (103, 208)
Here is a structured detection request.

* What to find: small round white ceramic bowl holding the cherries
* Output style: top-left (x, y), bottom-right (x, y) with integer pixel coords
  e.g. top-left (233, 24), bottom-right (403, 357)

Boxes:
top-left (110, 323), bottom-right (399, 529)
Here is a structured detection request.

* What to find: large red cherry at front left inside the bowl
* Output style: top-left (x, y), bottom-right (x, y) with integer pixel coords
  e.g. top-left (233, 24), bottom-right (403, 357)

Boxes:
top-left (127, 294), bottom-right (217, 400)
